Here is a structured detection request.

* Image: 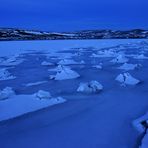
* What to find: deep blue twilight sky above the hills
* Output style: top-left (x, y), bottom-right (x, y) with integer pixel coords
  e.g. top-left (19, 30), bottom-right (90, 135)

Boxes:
top-left (0, 0), bottom-right (148, 31)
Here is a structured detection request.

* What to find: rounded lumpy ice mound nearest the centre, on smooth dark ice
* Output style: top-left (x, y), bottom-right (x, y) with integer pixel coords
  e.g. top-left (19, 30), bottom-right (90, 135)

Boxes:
top-left (77, 81), bottom-right (103, 93)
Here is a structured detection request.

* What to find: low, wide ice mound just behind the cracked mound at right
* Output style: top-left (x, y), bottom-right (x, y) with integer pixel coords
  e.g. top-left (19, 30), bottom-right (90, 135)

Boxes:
top-left (118, 63), bottom-right (141, 71)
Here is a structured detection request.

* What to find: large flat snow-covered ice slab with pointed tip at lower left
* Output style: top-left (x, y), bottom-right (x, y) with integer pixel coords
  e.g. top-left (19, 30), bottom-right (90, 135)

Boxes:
top-left (0, 94), bottom-right (66, 121)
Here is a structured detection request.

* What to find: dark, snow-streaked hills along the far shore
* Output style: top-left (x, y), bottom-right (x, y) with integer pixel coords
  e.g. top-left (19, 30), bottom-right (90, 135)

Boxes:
top-left (0, 28), bottom-right (148, 40)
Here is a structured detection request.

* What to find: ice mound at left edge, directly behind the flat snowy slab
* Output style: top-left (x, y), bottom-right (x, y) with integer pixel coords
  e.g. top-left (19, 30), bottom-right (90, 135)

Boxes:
top-left (0, 87), bottom-right (15, 100)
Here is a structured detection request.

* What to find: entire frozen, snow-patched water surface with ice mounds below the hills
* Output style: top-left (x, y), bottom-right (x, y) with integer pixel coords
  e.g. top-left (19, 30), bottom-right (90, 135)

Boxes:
top-left (0, 40), bottom-right (148, 148)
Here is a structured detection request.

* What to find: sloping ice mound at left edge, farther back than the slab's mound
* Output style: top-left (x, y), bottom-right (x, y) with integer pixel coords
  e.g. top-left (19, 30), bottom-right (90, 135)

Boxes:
top-left (0, 68), bottom-right (16, 80)
